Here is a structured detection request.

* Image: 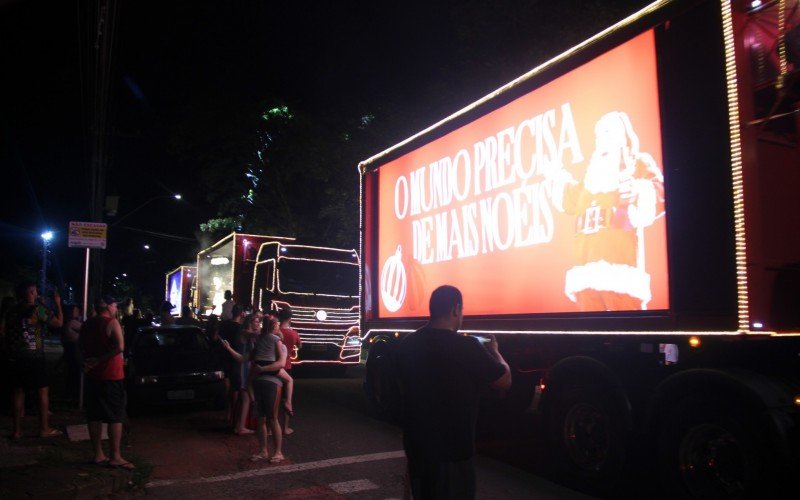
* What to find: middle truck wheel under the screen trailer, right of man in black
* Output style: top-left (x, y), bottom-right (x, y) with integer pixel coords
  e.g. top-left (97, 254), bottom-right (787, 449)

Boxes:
top-left (549, 387), bottom-right (627, 491)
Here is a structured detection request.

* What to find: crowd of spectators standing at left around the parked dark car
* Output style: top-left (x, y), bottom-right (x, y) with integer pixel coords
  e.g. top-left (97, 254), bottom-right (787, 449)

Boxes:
top-left (0, 282), bottom-right (300, 469)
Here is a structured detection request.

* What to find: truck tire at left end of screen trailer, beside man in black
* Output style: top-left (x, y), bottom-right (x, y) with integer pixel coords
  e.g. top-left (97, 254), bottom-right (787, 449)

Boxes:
top-left (364, 342), bottom-right (400, 422)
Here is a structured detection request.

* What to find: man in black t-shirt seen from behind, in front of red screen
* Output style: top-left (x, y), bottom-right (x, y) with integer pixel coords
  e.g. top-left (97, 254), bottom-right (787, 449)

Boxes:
top-left (397, 285), bottom-right (511, 499)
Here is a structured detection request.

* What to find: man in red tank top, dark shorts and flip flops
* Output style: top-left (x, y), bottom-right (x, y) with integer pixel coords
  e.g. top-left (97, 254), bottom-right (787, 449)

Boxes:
top-left (79, 295), bottom-right (136, 470)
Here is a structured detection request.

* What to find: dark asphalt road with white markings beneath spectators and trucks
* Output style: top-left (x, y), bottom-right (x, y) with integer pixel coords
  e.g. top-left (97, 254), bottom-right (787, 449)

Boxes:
top-left (130, 367), bottom-right (589, 499)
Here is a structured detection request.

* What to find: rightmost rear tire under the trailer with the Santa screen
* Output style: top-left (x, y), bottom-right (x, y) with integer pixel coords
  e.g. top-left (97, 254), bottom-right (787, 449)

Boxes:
top-left (658, 399), bottom-right (774, 498)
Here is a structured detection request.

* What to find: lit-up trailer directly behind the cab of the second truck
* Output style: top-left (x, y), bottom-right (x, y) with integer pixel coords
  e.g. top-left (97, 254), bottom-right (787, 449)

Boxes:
top-left (197, 233), bottom-right (294, 315)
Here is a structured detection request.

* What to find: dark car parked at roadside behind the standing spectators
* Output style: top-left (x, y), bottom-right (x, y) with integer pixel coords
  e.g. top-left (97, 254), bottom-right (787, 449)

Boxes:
top-left (126, 325), bottom-right (225, 408)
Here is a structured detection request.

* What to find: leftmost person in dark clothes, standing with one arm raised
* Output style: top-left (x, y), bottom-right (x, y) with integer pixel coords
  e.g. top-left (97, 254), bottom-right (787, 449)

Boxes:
top-left (2, 282), bottom-right (63, 439)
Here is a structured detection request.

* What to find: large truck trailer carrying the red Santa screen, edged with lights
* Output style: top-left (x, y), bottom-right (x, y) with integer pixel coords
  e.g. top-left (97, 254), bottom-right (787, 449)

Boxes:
top-left (359, 0), bottom-right (800, 498)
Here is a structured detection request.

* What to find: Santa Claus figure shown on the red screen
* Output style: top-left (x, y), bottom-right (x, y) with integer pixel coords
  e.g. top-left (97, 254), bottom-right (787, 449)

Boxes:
top-left (563, 111), bottom-right (664, 311)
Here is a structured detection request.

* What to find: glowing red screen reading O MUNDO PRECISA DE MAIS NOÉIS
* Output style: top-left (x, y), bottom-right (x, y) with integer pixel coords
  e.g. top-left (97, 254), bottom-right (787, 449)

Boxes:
top-left (370, 31), bottom-right (669, 318)
